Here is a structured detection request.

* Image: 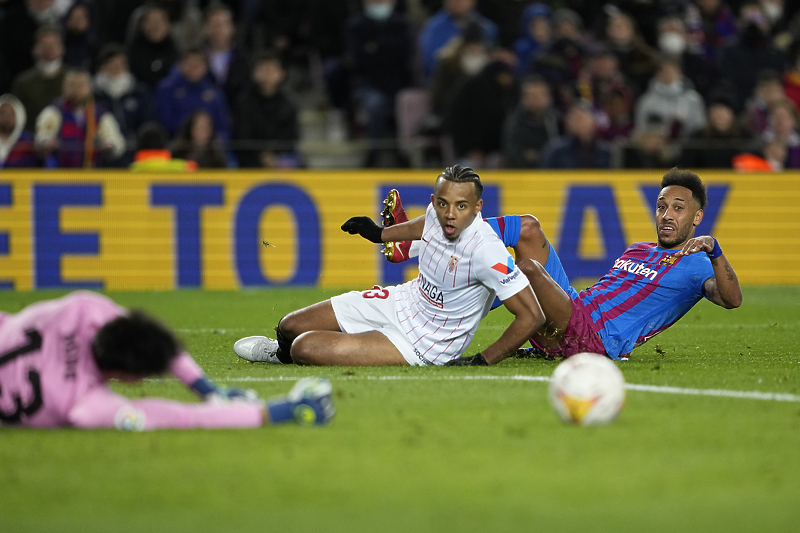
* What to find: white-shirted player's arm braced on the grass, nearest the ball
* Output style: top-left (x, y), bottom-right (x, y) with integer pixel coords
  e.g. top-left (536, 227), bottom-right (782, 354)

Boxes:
top-left (460, 285), bottom-right (544, 366)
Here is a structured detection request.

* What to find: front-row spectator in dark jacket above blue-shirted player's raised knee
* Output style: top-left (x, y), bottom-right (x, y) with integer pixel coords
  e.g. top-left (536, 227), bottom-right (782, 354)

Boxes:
top-left (503, 77), bottom-right (561, 168)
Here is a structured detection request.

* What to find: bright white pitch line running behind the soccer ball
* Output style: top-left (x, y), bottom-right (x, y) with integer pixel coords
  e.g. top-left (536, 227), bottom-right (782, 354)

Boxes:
top-left (195, 375), bottom-right (800, 403)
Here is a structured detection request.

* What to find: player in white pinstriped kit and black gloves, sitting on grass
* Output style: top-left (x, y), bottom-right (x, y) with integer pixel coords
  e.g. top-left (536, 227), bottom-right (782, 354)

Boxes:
top-left (234, 165), bottom-right (544, 365)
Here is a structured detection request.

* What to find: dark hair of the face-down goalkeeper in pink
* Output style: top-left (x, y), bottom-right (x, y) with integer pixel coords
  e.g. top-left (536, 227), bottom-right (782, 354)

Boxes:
top-left (92, 311), bottom-right (182, 376)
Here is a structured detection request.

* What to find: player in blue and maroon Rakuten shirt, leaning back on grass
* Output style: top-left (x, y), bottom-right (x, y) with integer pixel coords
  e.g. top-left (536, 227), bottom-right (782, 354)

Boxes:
top-left (382, 168), bottom-right (742, 364)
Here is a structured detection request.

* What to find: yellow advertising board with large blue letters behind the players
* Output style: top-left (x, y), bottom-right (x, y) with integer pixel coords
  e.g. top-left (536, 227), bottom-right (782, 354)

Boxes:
top-left (0, 170), bottom-right (800, 290)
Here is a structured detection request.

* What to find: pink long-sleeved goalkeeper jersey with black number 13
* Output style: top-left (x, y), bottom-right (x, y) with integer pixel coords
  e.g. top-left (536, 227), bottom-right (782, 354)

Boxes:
top-left (0, 292), bottom-right (262, 430)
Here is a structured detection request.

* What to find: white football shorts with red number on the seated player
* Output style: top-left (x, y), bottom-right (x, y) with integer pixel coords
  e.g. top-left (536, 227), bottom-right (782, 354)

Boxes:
top-left (331, 285), bottom-right (430, 366)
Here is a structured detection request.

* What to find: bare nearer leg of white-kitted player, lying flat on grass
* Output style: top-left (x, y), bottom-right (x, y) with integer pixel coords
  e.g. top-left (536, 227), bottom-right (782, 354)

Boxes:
top-left (291, 331), bottom-right (408, 366)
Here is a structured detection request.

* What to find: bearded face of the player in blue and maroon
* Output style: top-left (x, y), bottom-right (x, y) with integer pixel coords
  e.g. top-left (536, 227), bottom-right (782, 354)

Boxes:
top-left (656, 185), bottom-right (703, 249)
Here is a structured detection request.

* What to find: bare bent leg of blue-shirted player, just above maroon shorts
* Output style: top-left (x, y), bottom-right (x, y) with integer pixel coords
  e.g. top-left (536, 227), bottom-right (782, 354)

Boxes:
top-left (517, 259), bottom-right (572, 350)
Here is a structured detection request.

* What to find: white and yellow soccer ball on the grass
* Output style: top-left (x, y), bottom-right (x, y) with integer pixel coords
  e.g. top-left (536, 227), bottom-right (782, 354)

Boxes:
top-left (550, 353), bottom-right (625, 426)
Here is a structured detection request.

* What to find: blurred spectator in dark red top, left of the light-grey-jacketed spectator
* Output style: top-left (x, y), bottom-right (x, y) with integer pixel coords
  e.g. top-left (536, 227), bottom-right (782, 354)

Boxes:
top-left (578, 46), bottom-right (635, 141)
